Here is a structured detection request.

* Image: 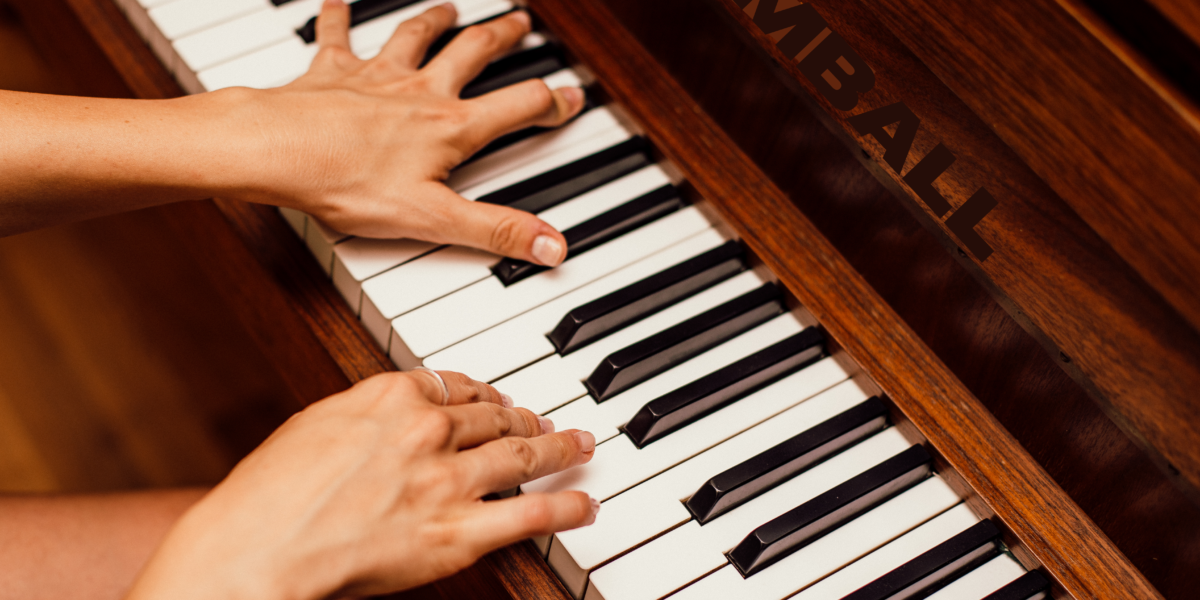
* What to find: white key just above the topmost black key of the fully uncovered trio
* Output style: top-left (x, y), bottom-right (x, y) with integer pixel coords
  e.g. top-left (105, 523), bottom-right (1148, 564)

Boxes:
top-left (425, 229), bottom-right (726, 381)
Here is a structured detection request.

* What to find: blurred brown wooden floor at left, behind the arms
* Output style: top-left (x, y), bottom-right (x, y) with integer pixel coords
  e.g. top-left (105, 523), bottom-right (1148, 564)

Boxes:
top-left (0, 4), bottom-right (295, 492)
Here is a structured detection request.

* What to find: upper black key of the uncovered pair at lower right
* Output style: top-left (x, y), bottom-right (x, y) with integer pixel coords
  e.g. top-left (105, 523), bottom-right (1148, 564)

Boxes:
top-left (684, 397), bottom-right (888, 524)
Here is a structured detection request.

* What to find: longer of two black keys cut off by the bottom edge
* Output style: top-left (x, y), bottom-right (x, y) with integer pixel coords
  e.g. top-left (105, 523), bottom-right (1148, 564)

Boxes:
top-left (842, 521), bottom-right (1000, 600)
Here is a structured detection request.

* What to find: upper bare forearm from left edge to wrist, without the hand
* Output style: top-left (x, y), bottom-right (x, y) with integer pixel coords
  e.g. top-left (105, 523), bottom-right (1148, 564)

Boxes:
top-left (0, 90), bottom-right (262, 236)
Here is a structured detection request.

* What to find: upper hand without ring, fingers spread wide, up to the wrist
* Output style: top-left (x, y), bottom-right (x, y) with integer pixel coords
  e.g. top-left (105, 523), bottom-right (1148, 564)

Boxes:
top-left (231, 0), bottom-right (584, 265)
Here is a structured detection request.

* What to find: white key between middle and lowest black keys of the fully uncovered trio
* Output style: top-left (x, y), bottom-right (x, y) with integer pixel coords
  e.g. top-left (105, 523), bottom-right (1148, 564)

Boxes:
top-left (546, 313), bottom-right (804, 443)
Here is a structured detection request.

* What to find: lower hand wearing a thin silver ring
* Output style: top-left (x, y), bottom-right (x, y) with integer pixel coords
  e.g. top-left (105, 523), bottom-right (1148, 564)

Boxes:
top-left (128, 371), bottom-right (599, 599)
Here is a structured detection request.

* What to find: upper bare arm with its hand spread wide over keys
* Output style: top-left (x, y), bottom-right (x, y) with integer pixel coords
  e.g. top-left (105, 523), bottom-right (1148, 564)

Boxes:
top-left (0, 0), bottom-right (583, 265)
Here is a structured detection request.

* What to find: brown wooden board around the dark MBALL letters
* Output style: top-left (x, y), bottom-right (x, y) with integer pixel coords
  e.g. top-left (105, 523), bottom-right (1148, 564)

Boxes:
top-left (705, 0), bottom-right (1200, 511)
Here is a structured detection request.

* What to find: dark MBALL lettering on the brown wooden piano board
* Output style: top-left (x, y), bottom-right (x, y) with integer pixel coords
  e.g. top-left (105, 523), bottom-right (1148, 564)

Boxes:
top-left (734, 0), bottom-right (998, 262)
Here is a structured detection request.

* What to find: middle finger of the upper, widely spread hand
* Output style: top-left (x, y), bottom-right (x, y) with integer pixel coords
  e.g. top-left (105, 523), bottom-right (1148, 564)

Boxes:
top-left (425, 11), bottom-right (532, 95)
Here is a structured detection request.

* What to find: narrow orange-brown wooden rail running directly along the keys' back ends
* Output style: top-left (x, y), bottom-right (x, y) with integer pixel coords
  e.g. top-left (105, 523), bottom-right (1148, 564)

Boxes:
top-left (532, 0), bottom-right (1158, 599)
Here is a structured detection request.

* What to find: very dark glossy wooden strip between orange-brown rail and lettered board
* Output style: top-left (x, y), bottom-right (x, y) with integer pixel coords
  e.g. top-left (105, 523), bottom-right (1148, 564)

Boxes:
top-left (597, 0), bottom-right (1200, 598)
